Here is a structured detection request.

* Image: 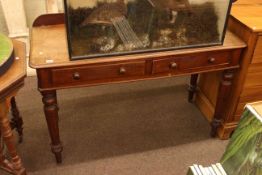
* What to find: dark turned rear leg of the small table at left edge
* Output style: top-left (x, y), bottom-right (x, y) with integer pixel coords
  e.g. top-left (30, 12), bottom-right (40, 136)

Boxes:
top-left (11, 97), bottom-right (23, 143)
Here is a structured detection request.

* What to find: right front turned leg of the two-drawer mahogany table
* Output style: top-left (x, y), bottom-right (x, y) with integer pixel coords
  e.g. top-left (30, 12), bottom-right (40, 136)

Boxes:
top-left (211, 70), bottom-right (234, 137)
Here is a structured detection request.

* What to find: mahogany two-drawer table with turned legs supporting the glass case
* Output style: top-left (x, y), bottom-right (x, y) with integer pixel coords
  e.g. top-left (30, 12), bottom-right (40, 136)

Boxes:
top-left (29, 14), bottom-right (246, 163)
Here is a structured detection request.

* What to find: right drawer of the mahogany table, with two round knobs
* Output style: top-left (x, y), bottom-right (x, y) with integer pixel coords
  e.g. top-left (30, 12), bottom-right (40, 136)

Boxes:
top-left (153, 52), bottom-right (230, 74)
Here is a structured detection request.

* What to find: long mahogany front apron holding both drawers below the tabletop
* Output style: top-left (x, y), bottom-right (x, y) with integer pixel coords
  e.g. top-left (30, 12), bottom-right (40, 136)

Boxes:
top-left (37, 49), bottom-right (241, 91)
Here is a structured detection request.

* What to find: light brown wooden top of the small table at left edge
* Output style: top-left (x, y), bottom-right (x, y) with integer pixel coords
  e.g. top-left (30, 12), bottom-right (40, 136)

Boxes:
top-left (0, 40), bottom-right (26, 97)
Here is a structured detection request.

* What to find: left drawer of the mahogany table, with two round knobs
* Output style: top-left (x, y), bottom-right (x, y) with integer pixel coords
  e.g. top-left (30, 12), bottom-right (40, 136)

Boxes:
top-left (52, 61), bottom-right (145, 85)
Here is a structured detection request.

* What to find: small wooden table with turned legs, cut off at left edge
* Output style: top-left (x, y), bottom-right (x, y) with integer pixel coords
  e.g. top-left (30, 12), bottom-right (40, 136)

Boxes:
top-left (0, 41), bottom-right (26, 175)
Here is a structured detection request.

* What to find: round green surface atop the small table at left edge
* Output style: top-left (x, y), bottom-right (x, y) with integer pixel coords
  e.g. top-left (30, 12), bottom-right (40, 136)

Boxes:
top-left (0, 33), bottom-right (13, 65)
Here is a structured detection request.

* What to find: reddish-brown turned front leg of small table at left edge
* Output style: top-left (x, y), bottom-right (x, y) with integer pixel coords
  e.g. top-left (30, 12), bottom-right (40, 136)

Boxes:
top-left (0, 101), bottom-right (26, 175)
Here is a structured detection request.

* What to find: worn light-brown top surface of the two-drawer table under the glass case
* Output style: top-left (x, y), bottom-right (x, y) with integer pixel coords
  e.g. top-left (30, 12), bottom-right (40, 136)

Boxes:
top-left (29, 24), bottom-right (246, 69)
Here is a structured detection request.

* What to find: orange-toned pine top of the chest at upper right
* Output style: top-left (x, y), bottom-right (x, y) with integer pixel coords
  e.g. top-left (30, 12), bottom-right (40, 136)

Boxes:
top-left (231, 4), bottom-right (262, 32)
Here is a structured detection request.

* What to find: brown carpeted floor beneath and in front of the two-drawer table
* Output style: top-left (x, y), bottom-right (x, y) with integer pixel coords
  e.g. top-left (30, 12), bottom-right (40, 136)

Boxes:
top-left (0, 77), bottom-right (227, 175)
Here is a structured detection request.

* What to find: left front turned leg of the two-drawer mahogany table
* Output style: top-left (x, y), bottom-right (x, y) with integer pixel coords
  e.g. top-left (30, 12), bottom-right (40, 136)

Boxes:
top-left (41, 90), bottom-right (63, 163)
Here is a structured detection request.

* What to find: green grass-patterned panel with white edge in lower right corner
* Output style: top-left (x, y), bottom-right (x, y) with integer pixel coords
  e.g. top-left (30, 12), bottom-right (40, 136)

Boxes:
top-left (221, 106), bottom-right (262, 175)
